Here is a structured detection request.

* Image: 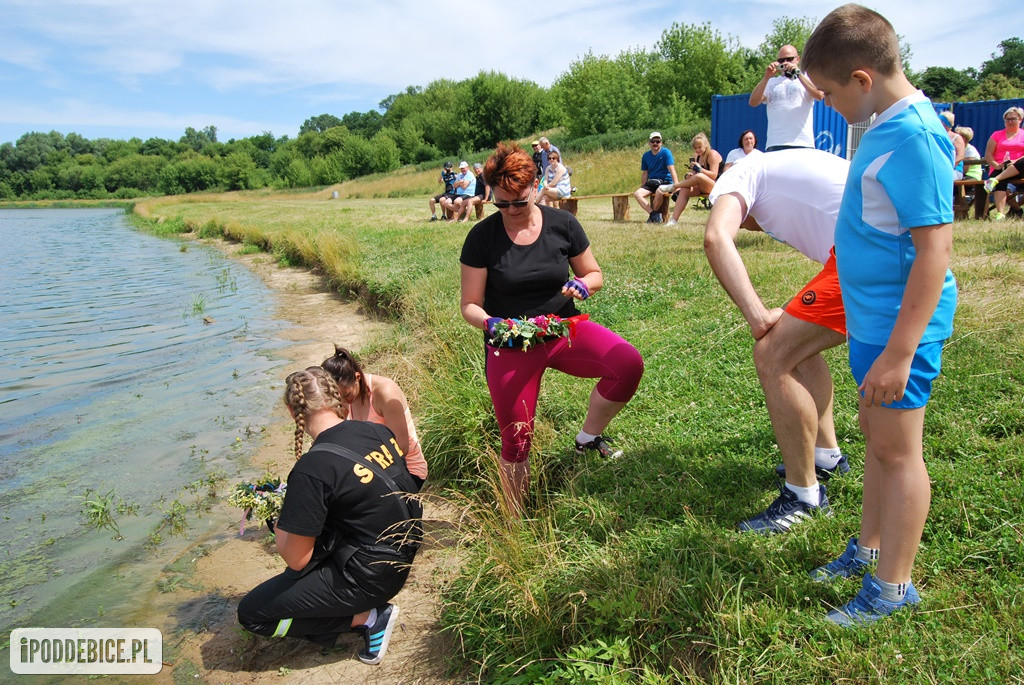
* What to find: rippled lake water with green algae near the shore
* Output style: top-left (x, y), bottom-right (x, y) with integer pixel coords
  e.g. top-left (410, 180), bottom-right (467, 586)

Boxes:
top-left (0, 209), bottom-right (285, 633)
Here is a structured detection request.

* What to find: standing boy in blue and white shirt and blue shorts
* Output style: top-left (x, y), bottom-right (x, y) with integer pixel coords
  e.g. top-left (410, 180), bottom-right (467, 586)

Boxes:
top-left (804, 4), bottom-right (956, 626)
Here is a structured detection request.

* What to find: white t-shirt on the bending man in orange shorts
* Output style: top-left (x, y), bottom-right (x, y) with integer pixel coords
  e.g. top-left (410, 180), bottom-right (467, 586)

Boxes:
top-left (708, 148), bottom-right (850, 264)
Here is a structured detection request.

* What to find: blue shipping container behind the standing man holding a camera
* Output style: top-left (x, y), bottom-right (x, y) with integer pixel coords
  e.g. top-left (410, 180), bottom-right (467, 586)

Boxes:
top-left (711, 93), bottom-right (848, 158)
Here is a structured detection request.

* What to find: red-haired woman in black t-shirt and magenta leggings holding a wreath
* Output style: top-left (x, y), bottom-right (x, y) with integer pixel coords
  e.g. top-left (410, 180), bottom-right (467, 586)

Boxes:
top-left (460, 143), bottom-right (643, 513)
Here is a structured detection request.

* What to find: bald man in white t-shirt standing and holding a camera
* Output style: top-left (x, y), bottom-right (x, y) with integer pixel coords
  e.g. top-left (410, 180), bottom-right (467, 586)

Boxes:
top-left (750, 45), bottom-right (824, 153)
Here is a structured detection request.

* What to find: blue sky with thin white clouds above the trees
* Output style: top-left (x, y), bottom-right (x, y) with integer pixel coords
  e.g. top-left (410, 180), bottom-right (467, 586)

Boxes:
top-left (0, 0), bottom-right (1024, 143)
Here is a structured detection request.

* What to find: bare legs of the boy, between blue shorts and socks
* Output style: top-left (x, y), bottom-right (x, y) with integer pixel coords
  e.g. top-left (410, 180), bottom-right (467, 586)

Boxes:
top-left (860, 400), bottom-right (932, 583)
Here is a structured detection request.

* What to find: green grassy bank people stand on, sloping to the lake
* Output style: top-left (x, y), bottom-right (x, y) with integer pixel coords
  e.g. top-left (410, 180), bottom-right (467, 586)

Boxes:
top-left (139, 183), bottom-right (1024, 683)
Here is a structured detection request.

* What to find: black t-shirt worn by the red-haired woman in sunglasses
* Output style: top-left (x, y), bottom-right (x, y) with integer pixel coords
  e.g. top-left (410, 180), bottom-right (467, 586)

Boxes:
top-left (459, 207), bottom-right (590, 318)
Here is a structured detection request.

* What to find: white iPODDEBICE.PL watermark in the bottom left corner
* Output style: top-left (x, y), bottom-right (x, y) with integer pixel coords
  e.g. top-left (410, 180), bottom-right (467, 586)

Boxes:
top-left (10, 628), bottom-right (164, 675)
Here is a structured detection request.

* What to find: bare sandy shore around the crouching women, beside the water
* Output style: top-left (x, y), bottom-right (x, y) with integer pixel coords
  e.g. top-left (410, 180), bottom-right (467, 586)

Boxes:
top-left (139, 237), bottom-right (456, 684)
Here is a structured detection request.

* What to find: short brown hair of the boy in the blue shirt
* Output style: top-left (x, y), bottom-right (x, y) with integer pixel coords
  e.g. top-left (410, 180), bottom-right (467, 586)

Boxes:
top-left (801, 4), bottom-right (903, 85)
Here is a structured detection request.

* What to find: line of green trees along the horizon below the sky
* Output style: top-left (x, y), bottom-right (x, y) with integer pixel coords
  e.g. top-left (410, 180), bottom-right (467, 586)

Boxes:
top-left (0, 17), bottom-right (1024, 200)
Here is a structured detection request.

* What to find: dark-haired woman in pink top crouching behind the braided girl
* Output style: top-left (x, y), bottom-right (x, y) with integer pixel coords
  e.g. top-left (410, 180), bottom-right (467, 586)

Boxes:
top-left (321, 345), bottom-right (427, 487)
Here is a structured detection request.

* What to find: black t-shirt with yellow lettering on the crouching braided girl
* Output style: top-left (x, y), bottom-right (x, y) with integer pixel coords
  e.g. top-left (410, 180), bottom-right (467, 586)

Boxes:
top-left (278, 421), bottom-right (423, 559)
